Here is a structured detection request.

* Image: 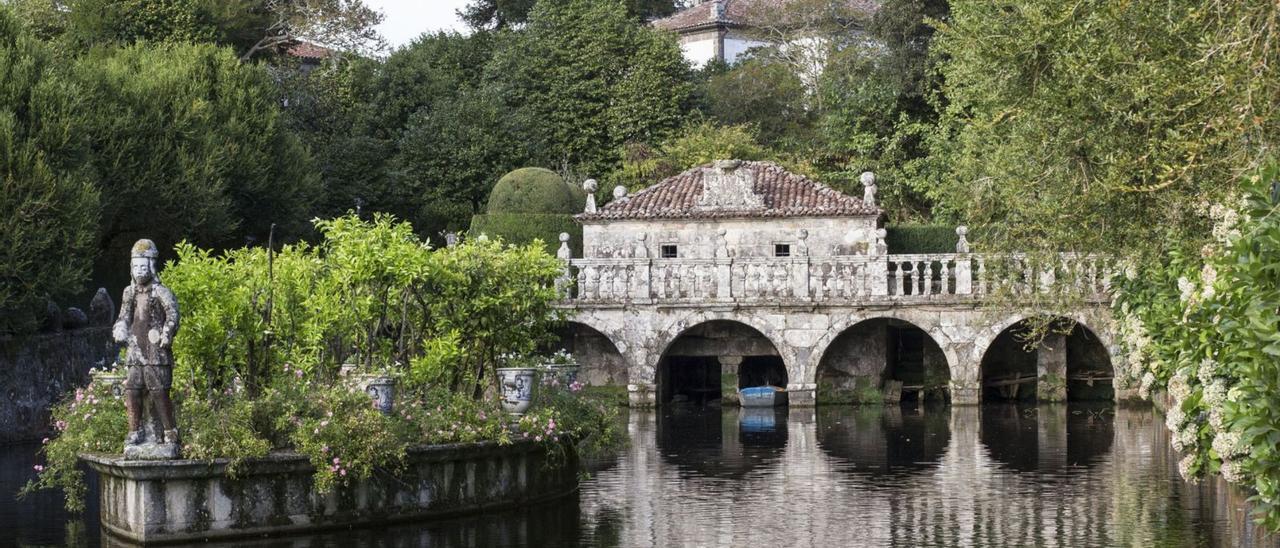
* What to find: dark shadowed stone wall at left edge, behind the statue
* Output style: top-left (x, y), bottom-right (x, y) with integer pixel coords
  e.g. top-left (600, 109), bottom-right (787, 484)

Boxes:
top-left (0, 326), bottom-right (116, 443)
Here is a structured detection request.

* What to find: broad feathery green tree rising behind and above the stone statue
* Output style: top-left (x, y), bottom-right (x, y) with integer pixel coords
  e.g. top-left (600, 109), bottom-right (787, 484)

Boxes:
top-left (73, 44), bottom-right (316, 282)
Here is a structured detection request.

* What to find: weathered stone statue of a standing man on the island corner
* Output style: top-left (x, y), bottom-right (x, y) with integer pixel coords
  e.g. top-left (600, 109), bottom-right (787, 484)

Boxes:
top-left (113, 239), bottom-right (179, 458)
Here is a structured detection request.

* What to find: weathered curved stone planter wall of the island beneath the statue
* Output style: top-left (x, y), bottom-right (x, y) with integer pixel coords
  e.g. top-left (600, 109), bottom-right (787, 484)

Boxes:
top-left (81, 443), bottom-right (577, 544)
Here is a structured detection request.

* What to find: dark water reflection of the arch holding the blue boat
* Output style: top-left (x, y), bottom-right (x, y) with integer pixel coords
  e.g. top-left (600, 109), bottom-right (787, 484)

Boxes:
top-left (657, 406), bottom-right (787, 478)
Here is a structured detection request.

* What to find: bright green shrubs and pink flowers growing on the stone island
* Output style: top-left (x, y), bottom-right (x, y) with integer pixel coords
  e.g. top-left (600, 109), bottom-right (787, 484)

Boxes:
top-left (27, 216), bottom-right (620, 507)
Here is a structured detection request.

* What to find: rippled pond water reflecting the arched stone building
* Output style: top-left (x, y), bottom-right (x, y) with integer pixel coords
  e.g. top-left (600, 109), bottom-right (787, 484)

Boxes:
top-left (0, 405), bottom-right (1280, 548)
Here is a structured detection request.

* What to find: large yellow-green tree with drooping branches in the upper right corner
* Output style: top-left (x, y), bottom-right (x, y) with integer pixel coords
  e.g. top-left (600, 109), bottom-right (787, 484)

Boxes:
top-left (933, 0), bottom-right (1280, 259)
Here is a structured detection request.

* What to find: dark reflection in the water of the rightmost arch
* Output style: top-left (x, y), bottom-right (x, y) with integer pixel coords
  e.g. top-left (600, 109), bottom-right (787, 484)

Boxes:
top-left (979, 402), bottom-right (1115, 479)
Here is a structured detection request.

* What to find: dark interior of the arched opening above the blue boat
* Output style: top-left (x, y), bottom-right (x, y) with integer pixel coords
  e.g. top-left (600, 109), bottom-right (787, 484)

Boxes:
top-left (657, 320), bottom-right (787, 403)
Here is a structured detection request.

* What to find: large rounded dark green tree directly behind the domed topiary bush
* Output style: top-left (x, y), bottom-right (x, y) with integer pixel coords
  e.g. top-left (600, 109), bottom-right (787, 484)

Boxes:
top-left (485, 0), bottom-right (691, 173)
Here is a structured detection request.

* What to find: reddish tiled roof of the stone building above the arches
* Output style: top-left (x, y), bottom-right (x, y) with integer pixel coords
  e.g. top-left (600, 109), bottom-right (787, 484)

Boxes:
top-left (577, 161), bottom-right (881, 222)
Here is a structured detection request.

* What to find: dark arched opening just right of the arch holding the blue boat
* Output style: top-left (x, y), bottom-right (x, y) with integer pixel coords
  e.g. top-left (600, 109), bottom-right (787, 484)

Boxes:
top-left (817, 318), bottom-right (951, 403)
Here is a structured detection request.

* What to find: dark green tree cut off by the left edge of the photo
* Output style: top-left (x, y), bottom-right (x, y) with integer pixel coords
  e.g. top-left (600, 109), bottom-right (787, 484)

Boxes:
top-left (0, 5), bottom-right (99, 333)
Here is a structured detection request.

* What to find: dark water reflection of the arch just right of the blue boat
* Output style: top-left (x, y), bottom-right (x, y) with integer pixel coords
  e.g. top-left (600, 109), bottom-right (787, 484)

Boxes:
top-left (818, 405), bottom-right (951, 479)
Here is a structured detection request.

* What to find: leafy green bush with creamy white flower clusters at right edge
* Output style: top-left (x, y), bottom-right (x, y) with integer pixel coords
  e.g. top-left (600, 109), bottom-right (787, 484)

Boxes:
top-left (1115, 165), bottom-right (1280, 530)
